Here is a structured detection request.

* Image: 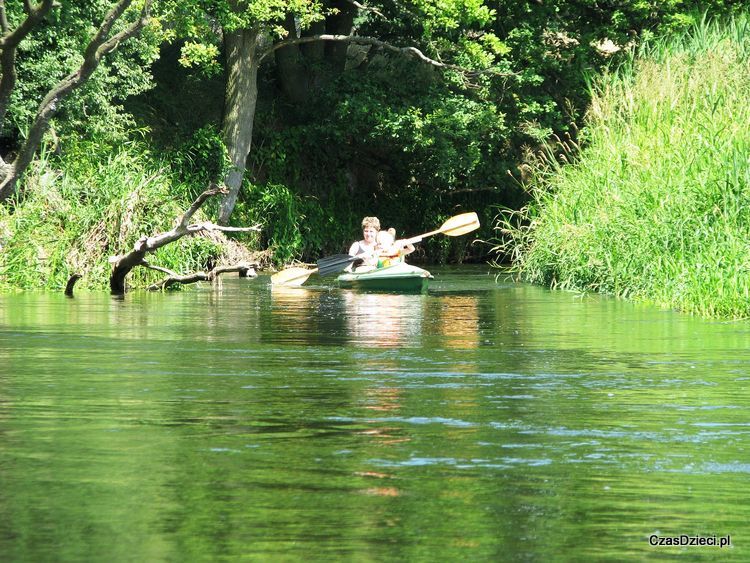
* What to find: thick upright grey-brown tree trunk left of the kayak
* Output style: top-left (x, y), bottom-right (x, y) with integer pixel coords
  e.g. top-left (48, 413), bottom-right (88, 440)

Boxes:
top-left (218, 29), bottom-right (260, 225)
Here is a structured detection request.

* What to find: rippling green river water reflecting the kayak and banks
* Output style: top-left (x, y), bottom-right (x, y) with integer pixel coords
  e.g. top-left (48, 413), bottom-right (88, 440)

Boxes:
top-left (0, 268), bottom-right (750, 561)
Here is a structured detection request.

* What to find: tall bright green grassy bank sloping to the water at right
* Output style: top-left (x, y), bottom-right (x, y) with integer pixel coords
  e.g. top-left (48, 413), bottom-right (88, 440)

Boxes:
top-left (499, 17), bottom-right (750, 318)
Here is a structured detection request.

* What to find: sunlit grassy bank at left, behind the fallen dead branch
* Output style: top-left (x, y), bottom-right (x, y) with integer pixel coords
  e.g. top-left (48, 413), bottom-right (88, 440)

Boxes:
top-left (0, 145), bottom-right (264, 291)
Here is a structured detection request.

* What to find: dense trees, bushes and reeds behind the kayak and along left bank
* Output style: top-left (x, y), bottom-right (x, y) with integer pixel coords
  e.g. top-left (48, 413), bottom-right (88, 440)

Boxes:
top-left (0, 0), bottom-right (738, 288)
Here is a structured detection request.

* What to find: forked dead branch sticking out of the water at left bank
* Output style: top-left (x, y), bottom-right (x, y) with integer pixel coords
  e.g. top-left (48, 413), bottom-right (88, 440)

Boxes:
top-left (109, 185), bottom-right (260, 295)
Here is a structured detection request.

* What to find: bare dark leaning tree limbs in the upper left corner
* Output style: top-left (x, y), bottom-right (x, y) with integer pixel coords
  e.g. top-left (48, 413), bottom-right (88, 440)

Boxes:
top-left (0, 0), bottom-right (152, 202)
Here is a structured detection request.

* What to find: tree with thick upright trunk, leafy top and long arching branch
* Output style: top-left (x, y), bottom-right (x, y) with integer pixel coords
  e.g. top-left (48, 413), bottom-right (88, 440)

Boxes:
top-left (165, 0), bottom-right (506, 224)
